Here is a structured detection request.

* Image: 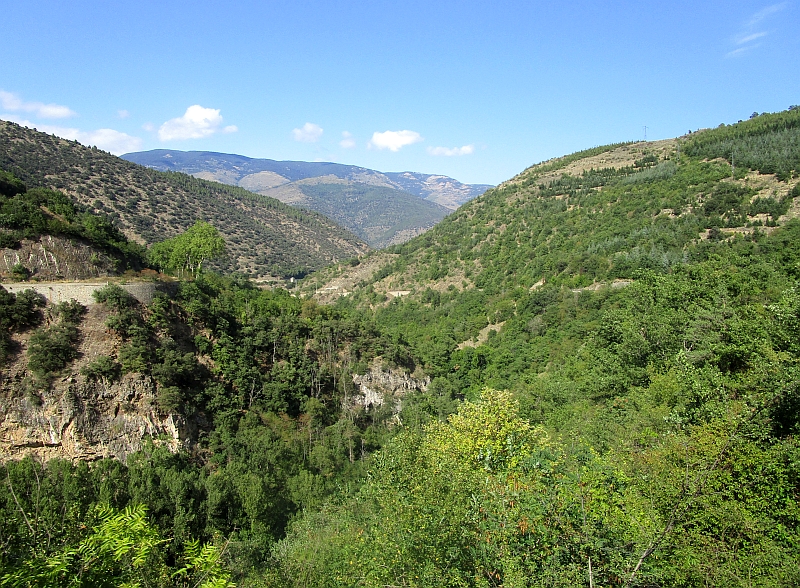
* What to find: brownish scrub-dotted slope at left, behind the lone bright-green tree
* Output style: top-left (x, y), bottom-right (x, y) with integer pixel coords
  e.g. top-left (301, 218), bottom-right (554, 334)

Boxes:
top-left (0, 121), bottom-right (367, 277)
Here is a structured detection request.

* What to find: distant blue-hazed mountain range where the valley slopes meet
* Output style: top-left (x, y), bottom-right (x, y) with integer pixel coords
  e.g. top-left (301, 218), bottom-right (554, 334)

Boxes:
top-left (122, 149), bottom-right (492, 248)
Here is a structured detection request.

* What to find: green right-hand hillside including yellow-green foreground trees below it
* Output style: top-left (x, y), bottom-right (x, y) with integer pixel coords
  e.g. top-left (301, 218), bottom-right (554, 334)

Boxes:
top-left (282, 110), bottom-right (800, 586)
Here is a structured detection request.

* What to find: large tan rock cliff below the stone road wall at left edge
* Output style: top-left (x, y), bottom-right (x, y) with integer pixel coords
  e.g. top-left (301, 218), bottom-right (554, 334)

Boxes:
top-left (0, 304), bottom-right (198, 461)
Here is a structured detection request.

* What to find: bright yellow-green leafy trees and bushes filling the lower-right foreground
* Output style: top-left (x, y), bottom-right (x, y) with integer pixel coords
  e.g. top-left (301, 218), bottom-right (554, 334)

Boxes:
top-left (270, 390), bottom-right (800, 587)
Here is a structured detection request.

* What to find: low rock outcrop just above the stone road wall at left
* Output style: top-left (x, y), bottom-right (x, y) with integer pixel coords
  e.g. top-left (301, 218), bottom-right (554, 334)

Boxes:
top-left (0, 235), bottom-right (116, 280)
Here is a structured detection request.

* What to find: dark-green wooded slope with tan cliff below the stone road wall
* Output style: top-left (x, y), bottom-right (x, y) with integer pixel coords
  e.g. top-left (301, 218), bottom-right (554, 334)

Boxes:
top-left (0, 275), bottom-right (412, 586)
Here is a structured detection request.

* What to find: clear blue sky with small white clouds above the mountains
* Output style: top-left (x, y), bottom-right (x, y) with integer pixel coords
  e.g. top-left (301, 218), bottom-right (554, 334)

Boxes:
top-left (0, 0), bottom-right (800, 183)
